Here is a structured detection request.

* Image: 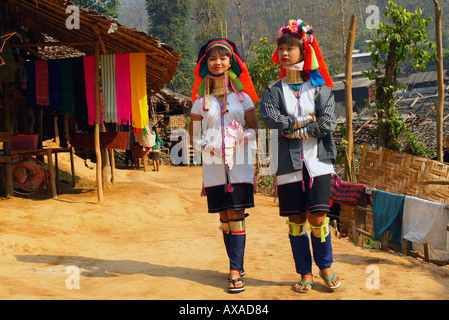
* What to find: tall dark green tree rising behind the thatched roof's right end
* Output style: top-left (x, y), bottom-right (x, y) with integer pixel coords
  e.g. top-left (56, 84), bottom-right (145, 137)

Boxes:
top-left (146, 0), bottom-right (195, 96)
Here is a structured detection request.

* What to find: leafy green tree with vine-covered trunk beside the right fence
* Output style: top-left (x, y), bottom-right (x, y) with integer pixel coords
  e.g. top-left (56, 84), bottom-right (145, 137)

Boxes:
top-left (365, 1), bottom-right (435, 150)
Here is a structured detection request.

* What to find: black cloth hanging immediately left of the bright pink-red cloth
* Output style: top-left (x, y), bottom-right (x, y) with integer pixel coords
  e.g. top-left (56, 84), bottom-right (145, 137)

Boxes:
top-left (72, 57), bottom-right (91, 131)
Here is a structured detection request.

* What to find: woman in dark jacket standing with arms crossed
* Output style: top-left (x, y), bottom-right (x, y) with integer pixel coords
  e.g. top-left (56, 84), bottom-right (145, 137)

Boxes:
top-left (260, 20), bottom-right (341, 293)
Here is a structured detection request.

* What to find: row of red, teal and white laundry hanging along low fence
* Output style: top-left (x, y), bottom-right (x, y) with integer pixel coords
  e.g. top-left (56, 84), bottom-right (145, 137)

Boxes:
top-left (332, 181), bottom-right (449, 260)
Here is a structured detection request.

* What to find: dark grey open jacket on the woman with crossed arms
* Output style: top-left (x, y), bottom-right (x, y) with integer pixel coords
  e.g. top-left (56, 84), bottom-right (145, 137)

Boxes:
top-left (260, 80), bottom-right (337, 175)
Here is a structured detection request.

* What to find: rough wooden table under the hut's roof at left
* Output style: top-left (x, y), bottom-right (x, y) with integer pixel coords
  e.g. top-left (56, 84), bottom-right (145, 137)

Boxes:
top-left (11, 147), bottom-right (76, 198)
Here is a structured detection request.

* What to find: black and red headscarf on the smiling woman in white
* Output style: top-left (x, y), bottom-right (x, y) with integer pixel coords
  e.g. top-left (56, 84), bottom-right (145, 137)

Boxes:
top-left (191, 39), bottom-right (259, 110)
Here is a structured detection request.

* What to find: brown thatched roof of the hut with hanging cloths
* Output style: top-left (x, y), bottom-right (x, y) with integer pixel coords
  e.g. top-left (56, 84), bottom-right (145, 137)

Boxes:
top-left (8, 0), bottom-right (180, 96)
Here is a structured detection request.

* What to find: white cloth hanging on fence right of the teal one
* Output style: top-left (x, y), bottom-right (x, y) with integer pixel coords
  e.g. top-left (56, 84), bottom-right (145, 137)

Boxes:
top-left (402, 196), bottom-right (447, 251)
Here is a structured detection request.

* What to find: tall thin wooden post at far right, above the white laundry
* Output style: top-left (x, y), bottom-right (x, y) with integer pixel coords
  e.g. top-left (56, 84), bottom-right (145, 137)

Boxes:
top-left (433, 0), bottom-right (444, 161)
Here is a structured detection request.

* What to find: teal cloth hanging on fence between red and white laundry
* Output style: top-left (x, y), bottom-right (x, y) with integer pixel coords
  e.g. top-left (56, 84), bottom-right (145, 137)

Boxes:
top-left (373, 190), bottom-right (405, 246)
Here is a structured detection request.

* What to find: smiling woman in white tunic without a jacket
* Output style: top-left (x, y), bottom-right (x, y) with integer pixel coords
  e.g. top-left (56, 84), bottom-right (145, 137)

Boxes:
top-left (189, 39), bottom-right (259, 293)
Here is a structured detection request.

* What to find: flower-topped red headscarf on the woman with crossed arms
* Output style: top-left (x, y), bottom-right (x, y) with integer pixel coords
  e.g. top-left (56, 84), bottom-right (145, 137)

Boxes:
top-left (271, 20), bottom-right (334, 88)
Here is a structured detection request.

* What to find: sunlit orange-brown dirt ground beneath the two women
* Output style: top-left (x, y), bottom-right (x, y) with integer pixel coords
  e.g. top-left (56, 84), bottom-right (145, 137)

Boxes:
top-left (0, 154), bottom-right (449, 300)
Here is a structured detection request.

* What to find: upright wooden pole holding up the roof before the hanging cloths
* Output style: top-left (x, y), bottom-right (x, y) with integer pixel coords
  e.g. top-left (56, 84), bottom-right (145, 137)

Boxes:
top-left (94, 42), bottom-right (103, 202)
